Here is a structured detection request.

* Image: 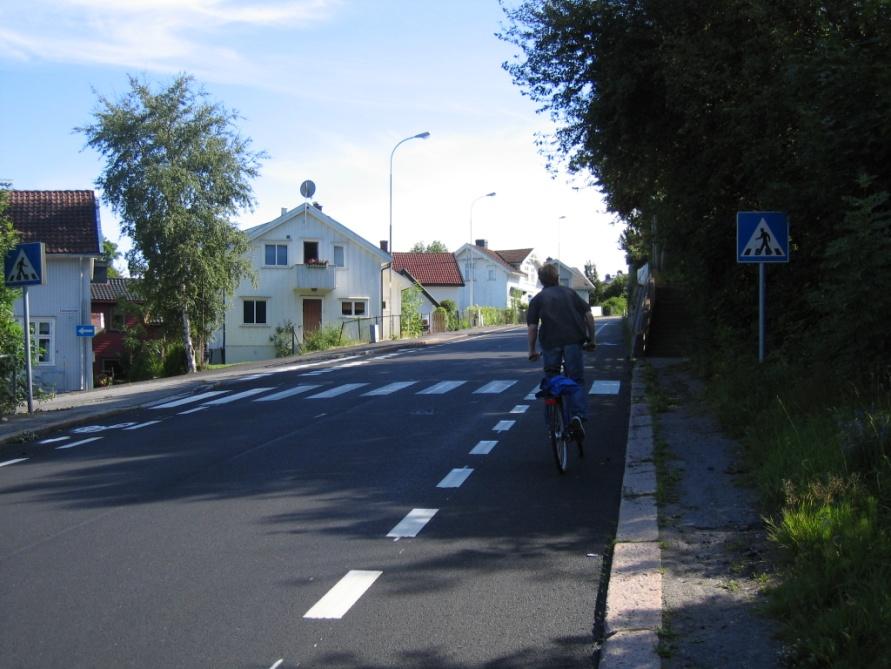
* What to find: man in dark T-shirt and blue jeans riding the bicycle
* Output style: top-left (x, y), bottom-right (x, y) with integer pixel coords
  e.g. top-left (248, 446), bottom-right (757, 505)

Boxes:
top-left (526, 264), bottom-right (595, 438)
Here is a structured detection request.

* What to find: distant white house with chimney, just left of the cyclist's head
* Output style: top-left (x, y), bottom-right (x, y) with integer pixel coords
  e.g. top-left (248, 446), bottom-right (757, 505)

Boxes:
top-left (455, 239), bottom-right (541, 310)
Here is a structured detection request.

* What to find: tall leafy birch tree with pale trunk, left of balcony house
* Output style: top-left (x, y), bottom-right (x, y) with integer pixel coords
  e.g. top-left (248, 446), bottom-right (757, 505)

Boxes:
top-left (78, 75), bottom-right (265, 372)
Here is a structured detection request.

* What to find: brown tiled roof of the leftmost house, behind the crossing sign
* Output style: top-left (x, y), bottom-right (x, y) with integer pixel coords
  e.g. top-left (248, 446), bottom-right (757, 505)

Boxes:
top-left (6, 190), bottom-right (101, 256)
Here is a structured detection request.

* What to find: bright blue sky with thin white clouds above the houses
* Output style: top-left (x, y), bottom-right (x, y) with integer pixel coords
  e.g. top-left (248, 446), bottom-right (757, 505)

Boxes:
top-left (0, 0), bottom-right (627, 278)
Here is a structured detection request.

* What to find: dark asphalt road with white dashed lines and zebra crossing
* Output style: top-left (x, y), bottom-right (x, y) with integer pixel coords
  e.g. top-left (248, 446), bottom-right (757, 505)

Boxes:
top-left (0, 319), bottom-right (629, 669)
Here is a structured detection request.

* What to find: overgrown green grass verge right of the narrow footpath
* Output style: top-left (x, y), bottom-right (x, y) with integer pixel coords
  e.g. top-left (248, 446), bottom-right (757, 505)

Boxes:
top-left (709, 355), bottom-right (891, 668)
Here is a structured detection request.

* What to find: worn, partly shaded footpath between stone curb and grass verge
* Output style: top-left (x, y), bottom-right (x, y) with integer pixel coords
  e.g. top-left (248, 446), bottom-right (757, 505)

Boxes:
top-left (648, 358), bottom-right (783, 669)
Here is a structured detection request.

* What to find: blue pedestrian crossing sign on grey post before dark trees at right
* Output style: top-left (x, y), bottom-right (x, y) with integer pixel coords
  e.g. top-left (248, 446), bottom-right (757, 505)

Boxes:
top-left (736, 211), bottom-right (789, 362)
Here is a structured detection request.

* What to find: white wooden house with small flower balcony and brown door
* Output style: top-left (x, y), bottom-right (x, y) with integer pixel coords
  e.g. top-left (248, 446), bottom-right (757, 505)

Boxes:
top-left (217, 203), bottom-right (392, 363)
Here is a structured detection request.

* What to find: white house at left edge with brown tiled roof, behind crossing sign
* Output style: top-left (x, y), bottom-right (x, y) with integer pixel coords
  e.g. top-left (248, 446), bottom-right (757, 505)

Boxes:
top-left (6, 190), bottom-right (102, 392)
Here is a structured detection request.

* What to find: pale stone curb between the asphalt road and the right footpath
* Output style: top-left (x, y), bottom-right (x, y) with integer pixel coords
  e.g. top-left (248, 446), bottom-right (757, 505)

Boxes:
top-left (599, 365), bottom-right (662, 669)
